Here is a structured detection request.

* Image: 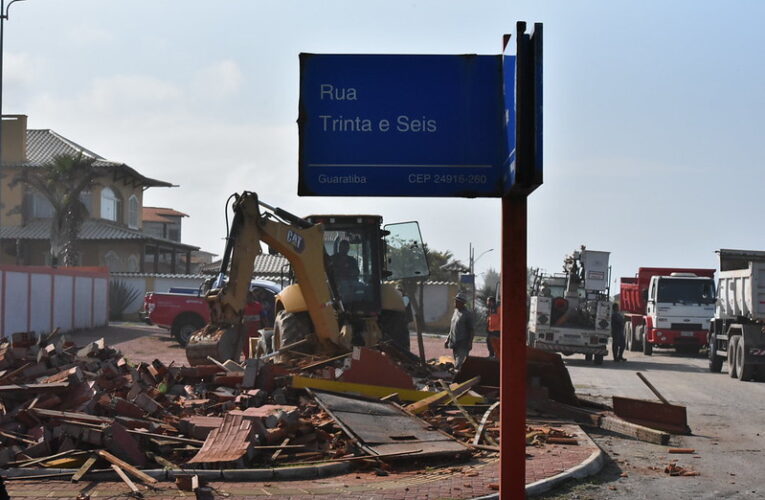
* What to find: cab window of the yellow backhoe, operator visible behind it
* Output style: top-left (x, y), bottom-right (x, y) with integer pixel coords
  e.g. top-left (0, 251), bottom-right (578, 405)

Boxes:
top-left (324, 230), bottom-right (375, 306)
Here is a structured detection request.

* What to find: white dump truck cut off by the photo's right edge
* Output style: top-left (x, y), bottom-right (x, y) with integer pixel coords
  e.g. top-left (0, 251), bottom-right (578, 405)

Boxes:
top-left (708, 249), bottom-right (765, 381)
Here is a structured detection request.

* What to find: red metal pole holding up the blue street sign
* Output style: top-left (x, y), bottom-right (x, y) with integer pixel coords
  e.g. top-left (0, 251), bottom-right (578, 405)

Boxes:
top-left (499, 195), bottom-right (527, 500)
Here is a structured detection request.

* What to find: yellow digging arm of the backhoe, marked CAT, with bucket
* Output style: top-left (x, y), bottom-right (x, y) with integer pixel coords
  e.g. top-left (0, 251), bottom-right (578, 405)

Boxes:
top-left (186, 191), bottom-right (350, 365)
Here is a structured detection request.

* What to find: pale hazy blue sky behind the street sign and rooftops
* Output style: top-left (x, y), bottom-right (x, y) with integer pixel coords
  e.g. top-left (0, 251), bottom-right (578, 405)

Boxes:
top-left (3, 0), bottom-right (765, 292)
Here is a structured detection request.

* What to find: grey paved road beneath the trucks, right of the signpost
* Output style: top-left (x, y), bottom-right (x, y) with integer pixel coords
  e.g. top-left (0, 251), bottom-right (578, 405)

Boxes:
top-left (545, 350), bottom-right (765, 500)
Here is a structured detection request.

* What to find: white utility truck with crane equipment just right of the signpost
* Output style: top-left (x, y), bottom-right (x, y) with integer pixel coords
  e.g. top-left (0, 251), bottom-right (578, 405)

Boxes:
top-left (528, 246), bottom-right (611, 365)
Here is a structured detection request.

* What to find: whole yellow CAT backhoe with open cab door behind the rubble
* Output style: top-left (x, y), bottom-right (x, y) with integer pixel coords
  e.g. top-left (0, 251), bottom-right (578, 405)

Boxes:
top-left (186, 192), bottom-right (429, 365)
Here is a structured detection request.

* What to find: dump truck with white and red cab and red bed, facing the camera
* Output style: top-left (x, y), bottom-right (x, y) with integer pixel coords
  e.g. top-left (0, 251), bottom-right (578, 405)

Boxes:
top-left (619, 267), bottom-right (715, 356)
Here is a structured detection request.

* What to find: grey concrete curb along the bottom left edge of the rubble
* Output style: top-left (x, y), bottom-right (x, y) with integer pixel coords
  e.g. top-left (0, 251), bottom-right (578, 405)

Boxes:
top-left (0, 462), bottom-right (351, 481)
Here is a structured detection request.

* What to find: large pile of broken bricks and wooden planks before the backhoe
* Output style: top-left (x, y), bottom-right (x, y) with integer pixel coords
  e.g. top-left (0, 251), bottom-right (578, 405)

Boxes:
top-left (0, 331), bottom-right (498, 480)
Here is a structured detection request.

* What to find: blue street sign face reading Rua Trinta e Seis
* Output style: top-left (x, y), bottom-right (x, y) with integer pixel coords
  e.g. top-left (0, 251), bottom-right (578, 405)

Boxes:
top-left (298, 54), bottom-right (515, 197)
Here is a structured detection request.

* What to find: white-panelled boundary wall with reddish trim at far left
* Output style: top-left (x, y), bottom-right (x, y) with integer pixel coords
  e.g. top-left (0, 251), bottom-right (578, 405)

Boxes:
top-left (0, 266), bottom-right (109, 337)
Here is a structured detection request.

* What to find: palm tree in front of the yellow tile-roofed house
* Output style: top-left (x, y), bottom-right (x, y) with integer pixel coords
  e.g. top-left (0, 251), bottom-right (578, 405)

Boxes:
top-left (11, 153), bottom-right (99, 267)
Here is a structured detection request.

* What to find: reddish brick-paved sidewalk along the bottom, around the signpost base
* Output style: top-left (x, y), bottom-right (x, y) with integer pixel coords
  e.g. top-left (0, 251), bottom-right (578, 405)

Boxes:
top-left (2, 426), bottom-right (597, 500)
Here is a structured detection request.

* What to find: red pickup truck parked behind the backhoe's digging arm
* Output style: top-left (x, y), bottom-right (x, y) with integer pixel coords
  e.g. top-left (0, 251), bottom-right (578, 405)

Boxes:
top-left (140, 280), bottom-right (281, 346)
